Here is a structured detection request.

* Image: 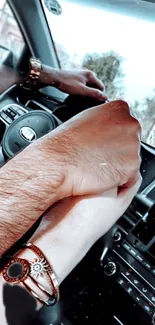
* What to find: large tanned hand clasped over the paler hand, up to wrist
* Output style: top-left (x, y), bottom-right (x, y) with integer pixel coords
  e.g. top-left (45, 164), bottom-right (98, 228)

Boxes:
top-left (45, 100), bottom-right (141, 196)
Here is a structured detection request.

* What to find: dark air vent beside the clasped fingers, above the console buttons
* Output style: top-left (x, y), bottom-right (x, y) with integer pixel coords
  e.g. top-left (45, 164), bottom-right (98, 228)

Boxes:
top-left (119, 198), bottom-right (148, 233)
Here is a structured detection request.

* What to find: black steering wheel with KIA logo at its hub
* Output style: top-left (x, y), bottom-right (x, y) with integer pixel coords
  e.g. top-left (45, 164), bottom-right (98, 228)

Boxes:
top-left (0, 86), bottom-right (62, 166)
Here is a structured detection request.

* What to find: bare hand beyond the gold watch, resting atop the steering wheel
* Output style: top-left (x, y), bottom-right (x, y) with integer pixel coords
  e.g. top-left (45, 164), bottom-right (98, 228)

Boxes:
top-left (41, 66), bottom-right (107, 101)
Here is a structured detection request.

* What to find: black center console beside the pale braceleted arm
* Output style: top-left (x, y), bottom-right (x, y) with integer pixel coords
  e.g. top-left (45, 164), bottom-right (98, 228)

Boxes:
top-left (62, 181), bottom-right (155, 325)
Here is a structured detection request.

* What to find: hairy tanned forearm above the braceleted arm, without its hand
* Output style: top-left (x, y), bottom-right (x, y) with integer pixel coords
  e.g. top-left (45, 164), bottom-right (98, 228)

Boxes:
top-left (0, 134), bottom-right (67, 255)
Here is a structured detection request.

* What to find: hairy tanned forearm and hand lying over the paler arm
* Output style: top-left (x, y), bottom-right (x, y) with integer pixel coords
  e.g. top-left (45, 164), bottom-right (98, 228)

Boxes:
top-left (0, 101), bottom-right (140, 254)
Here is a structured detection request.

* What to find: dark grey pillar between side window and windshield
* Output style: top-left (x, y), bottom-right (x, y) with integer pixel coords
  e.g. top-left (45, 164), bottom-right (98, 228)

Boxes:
top-left (8, 0), bottom-right (66, 101)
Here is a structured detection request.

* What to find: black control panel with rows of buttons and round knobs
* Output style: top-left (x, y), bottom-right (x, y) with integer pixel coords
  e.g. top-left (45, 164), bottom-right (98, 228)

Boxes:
top-left (101, 192), bottom-right (155, 324)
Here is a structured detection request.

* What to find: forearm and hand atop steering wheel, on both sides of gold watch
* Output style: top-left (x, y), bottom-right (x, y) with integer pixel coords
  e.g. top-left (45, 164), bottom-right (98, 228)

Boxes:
top-left (0, 65), bottom-right (107, 102)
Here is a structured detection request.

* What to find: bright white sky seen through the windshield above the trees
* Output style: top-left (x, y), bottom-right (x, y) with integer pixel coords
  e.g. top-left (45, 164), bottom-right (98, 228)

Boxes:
top-left (42, 0), bottom-right (155, 101)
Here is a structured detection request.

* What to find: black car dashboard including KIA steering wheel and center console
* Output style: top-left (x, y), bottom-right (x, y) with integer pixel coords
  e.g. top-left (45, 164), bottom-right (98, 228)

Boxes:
top-left (0, 86), bottom-right (155, 325)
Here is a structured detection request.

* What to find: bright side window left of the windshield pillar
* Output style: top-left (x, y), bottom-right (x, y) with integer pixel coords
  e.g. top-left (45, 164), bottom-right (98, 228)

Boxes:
top-left (0, 0), bottom-right (25, 67)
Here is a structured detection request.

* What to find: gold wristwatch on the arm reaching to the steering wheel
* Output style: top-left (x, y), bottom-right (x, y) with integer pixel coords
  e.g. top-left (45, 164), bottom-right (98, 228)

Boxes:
top-left (20, 58), bottom-right (42, 91)
